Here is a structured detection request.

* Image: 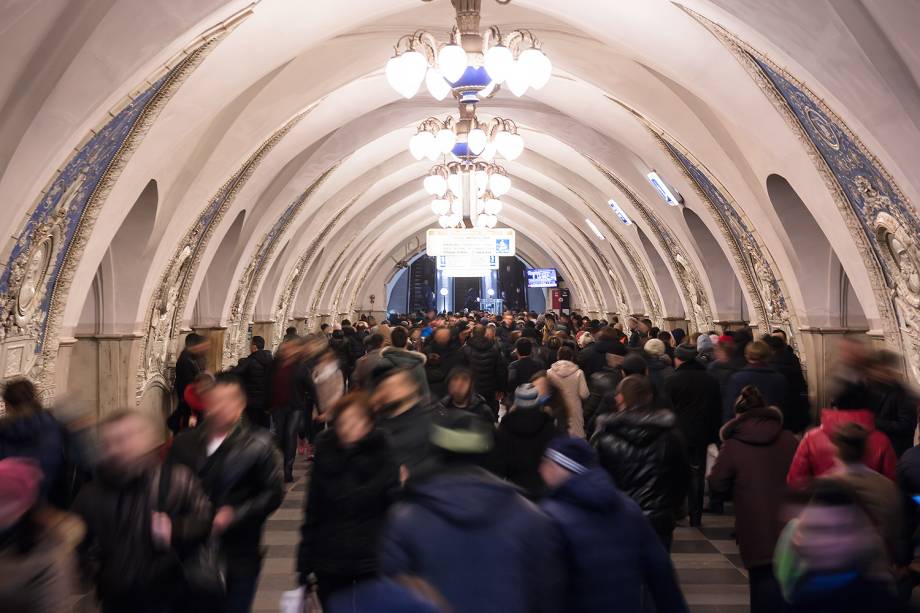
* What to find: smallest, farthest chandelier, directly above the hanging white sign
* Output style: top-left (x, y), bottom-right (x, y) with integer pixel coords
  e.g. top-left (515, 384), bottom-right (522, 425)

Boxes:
top-left (424, 161), bottom-right (511, 228)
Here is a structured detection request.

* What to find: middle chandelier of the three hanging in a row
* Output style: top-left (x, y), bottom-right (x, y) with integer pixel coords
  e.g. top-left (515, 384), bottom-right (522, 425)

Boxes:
top-left (409, 103), bottom-right (524, 162)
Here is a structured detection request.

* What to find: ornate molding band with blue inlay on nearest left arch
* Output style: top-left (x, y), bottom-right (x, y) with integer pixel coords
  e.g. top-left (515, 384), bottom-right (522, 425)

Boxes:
top-left (0, 11), bottom-right (252, 400)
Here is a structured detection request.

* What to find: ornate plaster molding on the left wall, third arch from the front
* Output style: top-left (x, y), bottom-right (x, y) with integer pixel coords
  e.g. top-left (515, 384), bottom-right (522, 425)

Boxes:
top-left (223, 162), bottom-right (340, 368)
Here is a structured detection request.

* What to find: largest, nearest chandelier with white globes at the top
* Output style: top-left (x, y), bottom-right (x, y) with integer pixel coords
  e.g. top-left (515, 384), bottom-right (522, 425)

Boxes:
top-left (386, 0), bottom-right (553, 103)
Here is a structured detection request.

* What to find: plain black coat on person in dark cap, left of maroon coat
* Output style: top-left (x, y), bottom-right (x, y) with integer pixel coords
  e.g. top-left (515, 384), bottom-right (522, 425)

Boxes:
top-left (664, 361), bottom-right (722, 449)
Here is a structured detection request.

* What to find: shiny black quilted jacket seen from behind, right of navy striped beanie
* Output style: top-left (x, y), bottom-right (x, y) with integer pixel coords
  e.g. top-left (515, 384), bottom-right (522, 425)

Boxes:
top-left (593, 408), bottom-right (690, 521)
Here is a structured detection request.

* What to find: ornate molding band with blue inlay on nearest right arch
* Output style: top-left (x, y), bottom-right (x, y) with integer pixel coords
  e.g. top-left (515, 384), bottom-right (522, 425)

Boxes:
top-left (678, 5), bottom-right (920, 381)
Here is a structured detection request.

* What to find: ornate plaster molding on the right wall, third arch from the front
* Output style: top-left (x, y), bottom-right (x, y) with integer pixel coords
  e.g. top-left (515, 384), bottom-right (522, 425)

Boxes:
top-left (585, 155), bottom-right (715, 332)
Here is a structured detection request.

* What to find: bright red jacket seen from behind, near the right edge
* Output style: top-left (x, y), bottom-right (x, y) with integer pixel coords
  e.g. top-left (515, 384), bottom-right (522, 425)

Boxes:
top-left (786, 409), bottom-right (898, 489)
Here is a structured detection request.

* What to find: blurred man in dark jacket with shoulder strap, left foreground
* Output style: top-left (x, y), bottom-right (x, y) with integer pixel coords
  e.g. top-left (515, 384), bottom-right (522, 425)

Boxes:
top-left (74, 410), bottom-right (215, 613)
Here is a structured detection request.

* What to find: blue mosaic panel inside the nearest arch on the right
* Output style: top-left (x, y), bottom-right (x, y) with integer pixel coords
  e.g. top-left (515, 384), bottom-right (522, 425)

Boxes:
top-left (748, 53), bottom-right (920, 283)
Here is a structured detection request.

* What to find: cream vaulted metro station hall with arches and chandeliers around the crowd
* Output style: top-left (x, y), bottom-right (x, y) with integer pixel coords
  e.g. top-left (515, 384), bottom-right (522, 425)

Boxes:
top-left (0, 0), bottom-right (920, 612)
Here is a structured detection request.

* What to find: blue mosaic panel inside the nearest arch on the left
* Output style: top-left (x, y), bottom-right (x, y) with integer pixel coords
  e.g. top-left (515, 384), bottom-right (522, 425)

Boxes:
top-left (0, 64), bottom-right (176, 353)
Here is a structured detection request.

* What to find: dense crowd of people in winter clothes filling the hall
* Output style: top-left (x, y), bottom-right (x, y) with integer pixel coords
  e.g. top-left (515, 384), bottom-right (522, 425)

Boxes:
top-left (0, 311), bottom-right (920, 613)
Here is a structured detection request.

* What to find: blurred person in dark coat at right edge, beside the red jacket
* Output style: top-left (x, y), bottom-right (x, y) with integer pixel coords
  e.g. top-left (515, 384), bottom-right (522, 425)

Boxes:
top-left (869, 349), bottom-right (918, 457)
